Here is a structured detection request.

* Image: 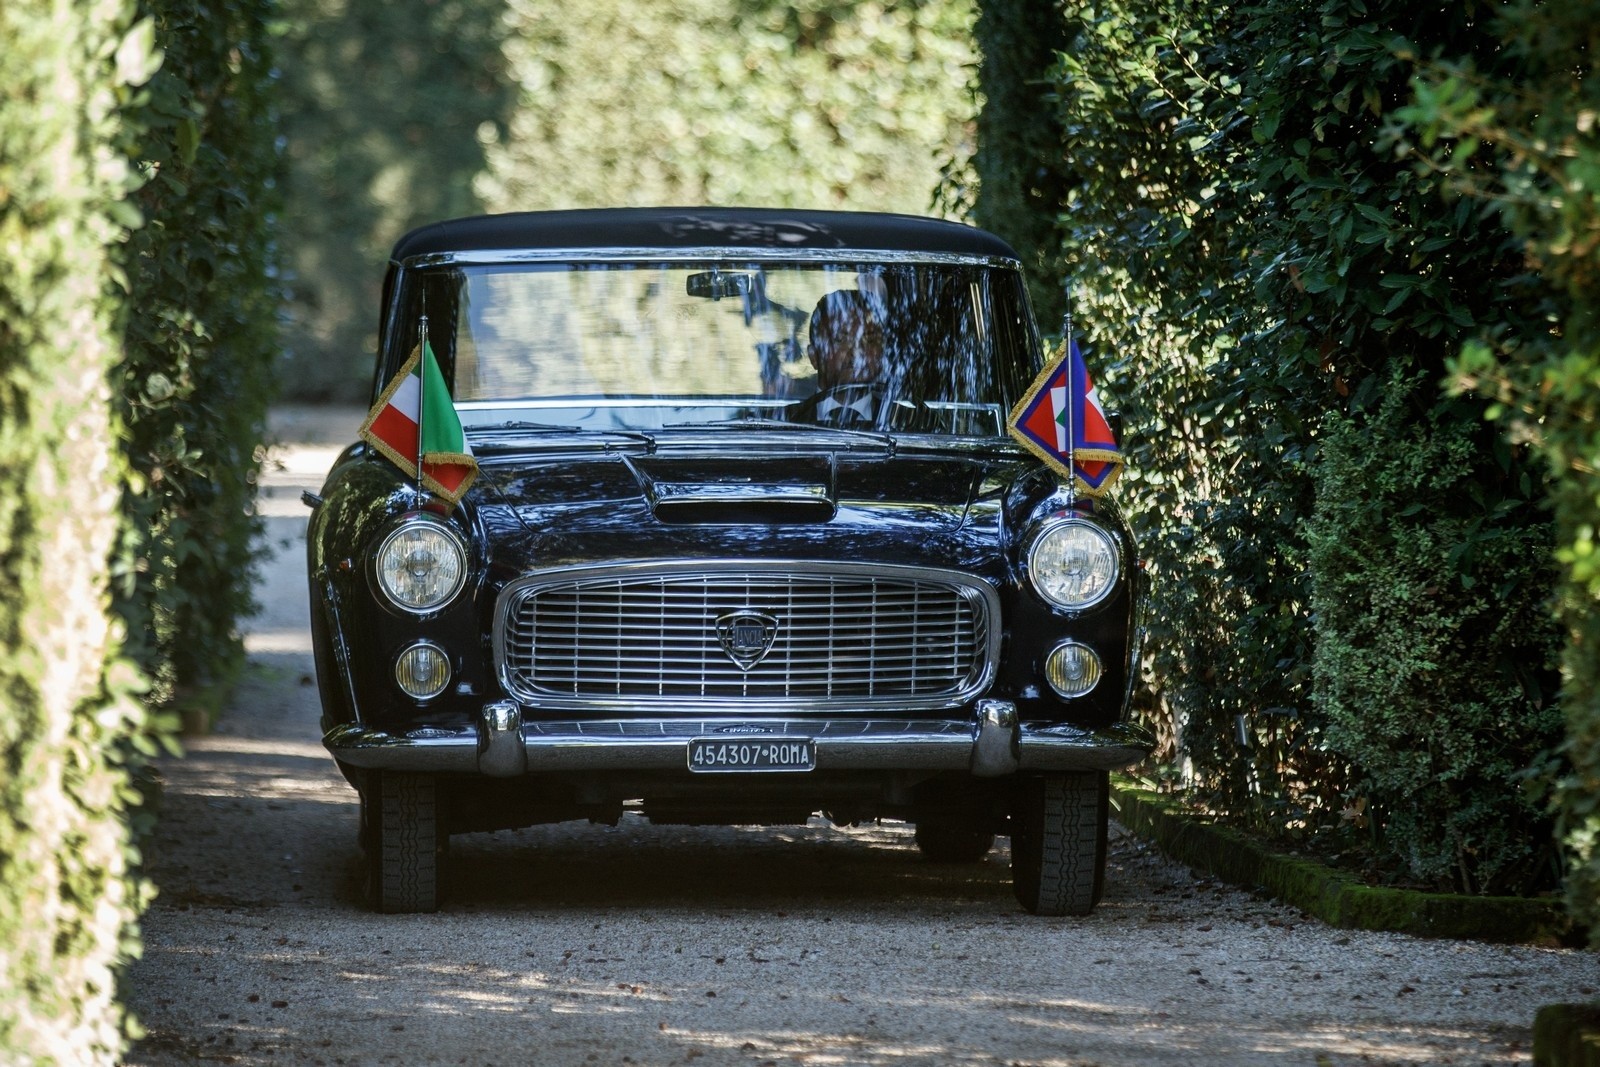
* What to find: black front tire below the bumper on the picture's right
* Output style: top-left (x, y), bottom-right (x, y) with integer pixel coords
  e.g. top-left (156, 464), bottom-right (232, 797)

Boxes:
top-left (1011, 771), bottom-right (1110, 915)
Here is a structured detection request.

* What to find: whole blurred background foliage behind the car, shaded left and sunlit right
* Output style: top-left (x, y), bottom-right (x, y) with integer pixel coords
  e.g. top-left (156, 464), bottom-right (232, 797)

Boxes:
top-left (273, 0), bottom-right (973, 398)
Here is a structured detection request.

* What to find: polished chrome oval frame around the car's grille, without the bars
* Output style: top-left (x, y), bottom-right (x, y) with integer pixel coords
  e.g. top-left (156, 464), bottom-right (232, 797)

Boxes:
top-left (493, 560), bottom-right (1002, 715)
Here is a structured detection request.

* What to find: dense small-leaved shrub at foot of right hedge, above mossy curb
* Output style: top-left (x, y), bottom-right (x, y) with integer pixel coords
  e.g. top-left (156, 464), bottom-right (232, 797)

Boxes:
top-left (1307, 368), bottom-right (1562, 894)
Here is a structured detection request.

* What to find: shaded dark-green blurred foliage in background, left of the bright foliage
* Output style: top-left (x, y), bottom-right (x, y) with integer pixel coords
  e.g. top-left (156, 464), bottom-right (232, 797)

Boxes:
top-left (275, 0), bottom-right (515, 400)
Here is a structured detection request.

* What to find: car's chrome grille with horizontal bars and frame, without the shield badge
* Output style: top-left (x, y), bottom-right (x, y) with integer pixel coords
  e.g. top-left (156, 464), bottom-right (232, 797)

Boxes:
top-left (494, 560), bottom-right (1000, 713)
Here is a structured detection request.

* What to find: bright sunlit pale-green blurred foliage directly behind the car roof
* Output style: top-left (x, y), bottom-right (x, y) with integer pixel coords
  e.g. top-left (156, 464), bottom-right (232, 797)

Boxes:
top-left (478, 0), bottom-right (971, 213)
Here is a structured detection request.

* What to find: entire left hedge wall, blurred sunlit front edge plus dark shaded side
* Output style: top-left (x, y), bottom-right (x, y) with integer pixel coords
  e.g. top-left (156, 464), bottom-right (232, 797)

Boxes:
top-left (0, 0), bottom-right (277, 1067)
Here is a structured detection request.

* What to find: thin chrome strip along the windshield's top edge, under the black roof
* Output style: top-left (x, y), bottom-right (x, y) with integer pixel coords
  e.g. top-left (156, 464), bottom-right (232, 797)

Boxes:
top-left (390, 245), bottom-right (1021, 270)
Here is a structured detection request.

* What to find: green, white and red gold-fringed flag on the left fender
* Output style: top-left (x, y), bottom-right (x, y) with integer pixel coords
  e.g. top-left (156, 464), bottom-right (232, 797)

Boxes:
top-left (362, 338), bottom-right (478, 504)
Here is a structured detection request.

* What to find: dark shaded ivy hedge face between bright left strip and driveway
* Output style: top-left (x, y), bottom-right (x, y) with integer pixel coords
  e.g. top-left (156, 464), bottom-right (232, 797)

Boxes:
top-left (115, 0), bottom-right (282, 710)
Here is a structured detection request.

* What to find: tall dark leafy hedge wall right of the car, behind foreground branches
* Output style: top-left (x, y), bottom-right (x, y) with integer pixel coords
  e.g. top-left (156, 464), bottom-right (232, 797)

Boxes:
top-left (978, 0), bottom-right (1562, 893)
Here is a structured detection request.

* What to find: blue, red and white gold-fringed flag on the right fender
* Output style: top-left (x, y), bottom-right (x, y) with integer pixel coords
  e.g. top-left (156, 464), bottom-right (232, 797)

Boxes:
top-left (1010, 341), bottom-right (1122, 496)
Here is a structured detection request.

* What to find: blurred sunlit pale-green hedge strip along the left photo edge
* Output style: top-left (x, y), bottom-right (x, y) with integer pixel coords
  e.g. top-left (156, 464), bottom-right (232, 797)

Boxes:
top-left (0, 0), bottom-right (154, 1067)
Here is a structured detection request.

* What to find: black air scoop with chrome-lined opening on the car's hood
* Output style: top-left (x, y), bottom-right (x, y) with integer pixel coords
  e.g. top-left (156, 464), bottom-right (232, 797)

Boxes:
top-left (632, 456), bottom-right (837, 526)
